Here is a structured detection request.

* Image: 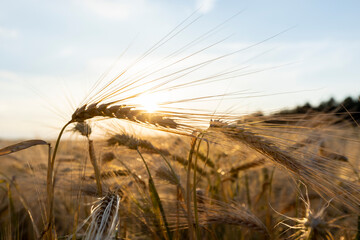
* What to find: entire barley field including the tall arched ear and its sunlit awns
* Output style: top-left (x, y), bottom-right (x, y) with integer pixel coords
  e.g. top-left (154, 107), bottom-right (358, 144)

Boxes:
top-left (0, 13), bottom-right (360, 240)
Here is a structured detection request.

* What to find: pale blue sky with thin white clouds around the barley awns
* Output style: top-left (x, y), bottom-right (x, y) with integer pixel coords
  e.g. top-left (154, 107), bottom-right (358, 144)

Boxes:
top-left (0, 0), bottom-right (360, 139)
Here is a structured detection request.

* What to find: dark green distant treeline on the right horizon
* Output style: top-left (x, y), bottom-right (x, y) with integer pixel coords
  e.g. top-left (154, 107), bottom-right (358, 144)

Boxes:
top-left (275, 96), bottom-right (360, 125)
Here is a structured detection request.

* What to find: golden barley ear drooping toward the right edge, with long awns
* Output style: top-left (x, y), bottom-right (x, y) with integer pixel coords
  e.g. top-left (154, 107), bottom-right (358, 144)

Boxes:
top-left (210, 122), bottom-right (360, 212)
